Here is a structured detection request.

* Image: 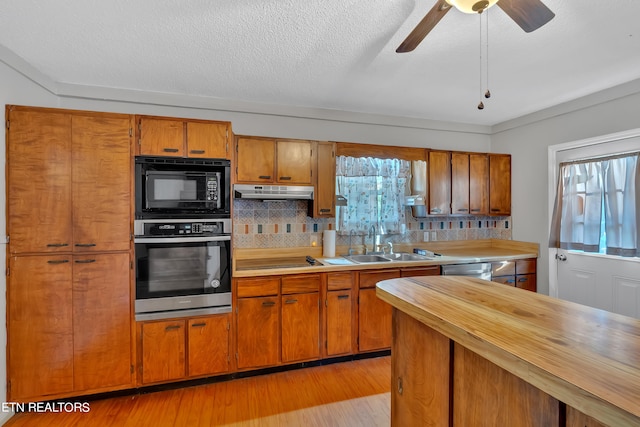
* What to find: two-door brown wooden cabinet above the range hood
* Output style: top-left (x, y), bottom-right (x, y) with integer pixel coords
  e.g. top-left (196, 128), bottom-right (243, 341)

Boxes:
top-left (236, 136), bottom-right (317, 185)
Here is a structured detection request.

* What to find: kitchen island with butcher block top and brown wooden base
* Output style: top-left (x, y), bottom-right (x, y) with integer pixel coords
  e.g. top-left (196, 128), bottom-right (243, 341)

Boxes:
top-left (376, 276), bottom-right (640, 427)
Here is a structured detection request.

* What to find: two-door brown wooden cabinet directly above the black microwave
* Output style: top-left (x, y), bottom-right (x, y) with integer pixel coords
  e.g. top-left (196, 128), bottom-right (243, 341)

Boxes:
top-left (136, 116), bottom-right (231, 159)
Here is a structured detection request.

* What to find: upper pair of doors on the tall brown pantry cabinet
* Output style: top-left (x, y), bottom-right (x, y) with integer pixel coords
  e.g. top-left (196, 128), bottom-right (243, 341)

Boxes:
top-left (7, 107), bottom-right (132, 254)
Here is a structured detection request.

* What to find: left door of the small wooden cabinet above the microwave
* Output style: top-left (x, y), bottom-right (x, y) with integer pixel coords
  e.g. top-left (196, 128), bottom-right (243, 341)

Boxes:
top-left (138, 117), bottom-right (185, 157)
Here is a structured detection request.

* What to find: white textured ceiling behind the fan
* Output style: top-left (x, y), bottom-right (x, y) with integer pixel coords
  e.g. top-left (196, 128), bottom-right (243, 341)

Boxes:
top-left (0, 0), bottom-right (640, 125)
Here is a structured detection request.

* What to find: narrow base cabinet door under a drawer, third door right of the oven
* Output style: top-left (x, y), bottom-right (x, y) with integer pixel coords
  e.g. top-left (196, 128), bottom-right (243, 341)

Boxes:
top-left (326, 289), bottom-right (354, 356)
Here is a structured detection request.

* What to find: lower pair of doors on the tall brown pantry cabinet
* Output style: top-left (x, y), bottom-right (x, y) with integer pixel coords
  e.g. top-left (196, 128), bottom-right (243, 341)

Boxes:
top-left (7, 253), bottom-right (134, 401)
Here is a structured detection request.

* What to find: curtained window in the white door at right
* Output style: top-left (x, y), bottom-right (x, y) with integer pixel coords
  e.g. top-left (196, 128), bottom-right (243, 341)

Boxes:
top-left (549, 153), bottom-right (640, 257)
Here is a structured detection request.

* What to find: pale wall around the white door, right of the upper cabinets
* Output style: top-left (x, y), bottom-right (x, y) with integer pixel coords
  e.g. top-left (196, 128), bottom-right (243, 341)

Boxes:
top-left (491, 82), bottom-right (640, 294)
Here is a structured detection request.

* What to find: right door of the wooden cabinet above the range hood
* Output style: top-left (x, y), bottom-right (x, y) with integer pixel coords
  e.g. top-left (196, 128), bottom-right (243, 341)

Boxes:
top-left (276, 141), bottom-right (313, 184)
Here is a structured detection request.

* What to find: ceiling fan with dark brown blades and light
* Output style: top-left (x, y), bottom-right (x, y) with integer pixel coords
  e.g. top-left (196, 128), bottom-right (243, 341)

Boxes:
top-left (396, 0), bottom-right (555, 53)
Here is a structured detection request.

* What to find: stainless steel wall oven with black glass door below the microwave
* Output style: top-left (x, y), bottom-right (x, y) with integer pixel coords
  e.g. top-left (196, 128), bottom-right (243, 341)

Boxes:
top-left (134, 218), bottom-right (231, 320)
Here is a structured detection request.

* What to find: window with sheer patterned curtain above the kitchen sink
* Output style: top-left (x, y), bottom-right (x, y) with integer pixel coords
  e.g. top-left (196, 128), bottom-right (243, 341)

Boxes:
top-left (336, 156), bottom-right (411, 234)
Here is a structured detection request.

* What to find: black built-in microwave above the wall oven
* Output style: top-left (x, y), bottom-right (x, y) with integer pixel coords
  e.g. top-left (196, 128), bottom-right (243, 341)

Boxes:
top-left (135, 156), bottom-right (231, 219)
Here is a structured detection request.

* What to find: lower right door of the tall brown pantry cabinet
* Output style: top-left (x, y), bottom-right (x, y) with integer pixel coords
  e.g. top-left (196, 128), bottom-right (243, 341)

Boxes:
top-left (73, 253), bottom-right (133, 391)
